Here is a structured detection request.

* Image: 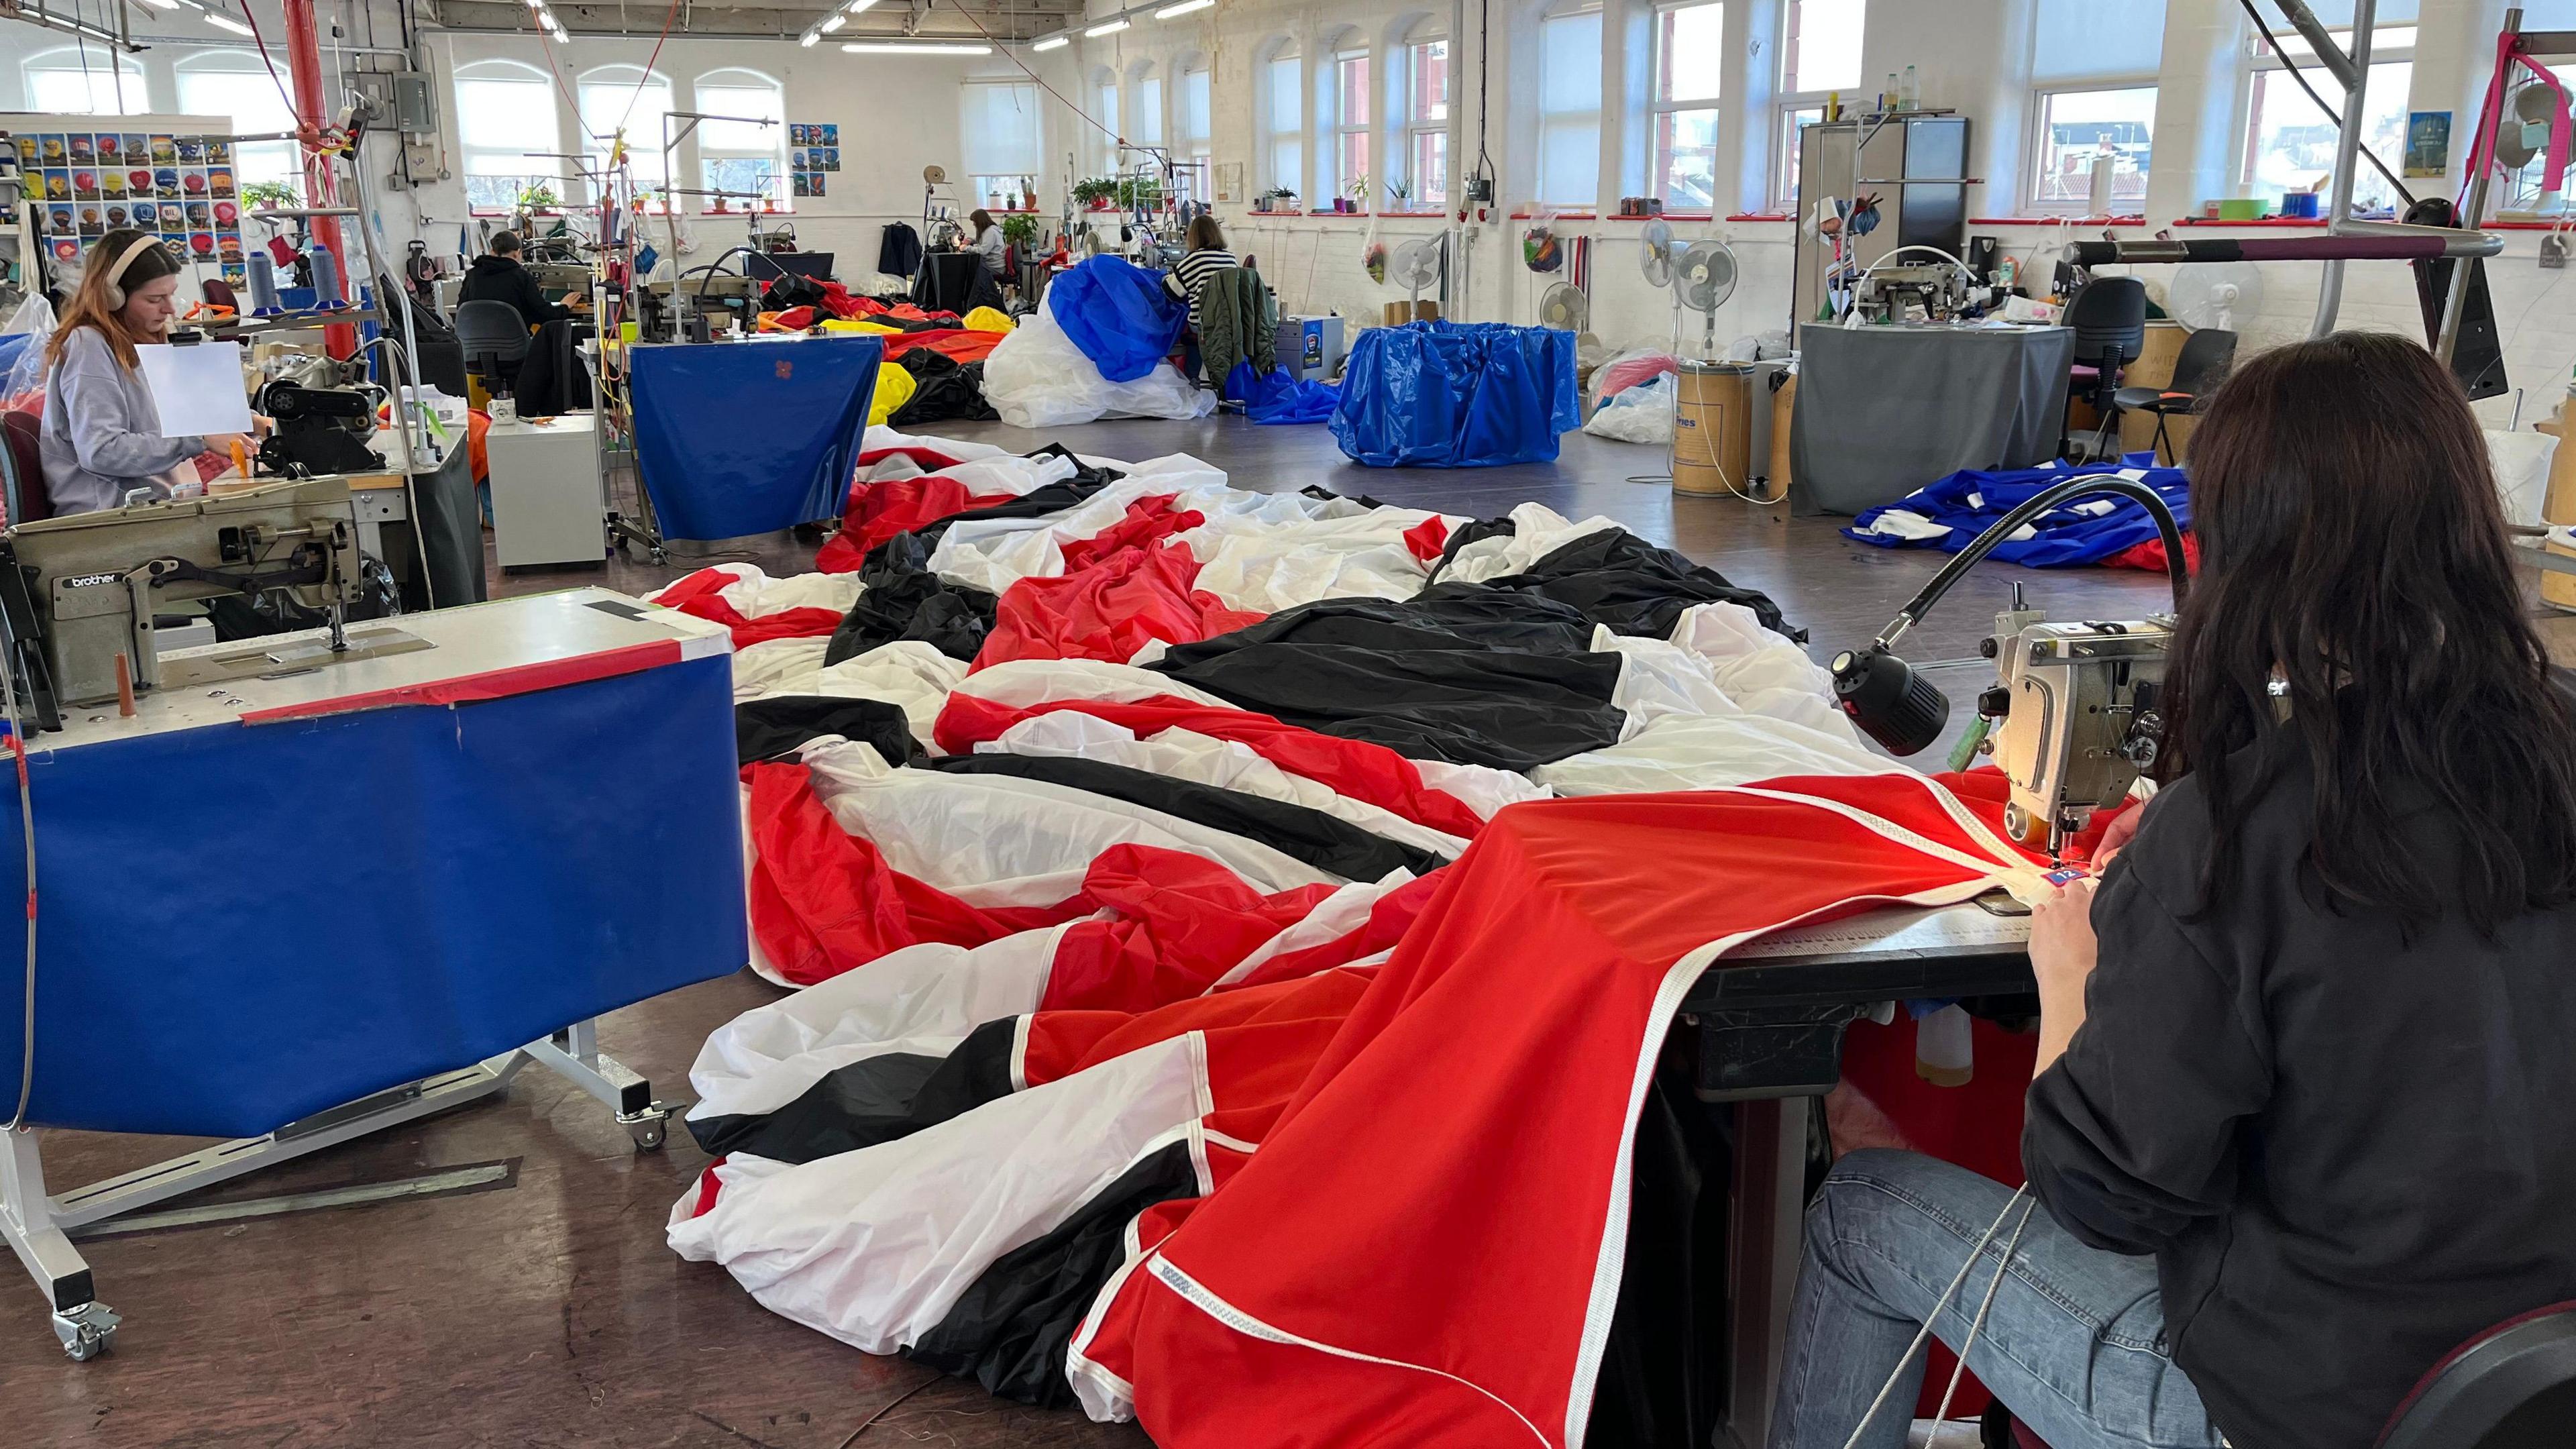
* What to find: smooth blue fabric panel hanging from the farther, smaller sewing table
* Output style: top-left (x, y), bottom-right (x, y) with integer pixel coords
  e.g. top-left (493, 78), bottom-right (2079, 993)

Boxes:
top-left (626, 335), bottom-right (886, 539)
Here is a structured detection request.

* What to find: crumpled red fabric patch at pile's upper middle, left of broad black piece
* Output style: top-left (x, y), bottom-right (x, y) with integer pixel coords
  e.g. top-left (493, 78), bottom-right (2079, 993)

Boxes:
top-left (974, 539), bottom-right (1263, 667)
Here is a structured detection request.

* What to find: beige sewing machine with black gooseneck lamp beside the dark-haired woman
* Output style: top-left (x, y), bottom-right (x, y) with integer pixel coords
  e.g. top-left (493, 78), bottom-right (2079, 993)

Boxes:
top-left (1834, 474), bottom-right (2190, 859)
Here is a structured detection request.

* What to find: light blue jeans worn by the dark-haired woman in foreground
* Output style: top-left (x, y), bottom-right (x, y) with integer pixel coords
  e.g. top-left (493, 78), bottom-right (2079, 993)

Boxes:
top-left (1770, 1150), bottom-right (2223, 1449)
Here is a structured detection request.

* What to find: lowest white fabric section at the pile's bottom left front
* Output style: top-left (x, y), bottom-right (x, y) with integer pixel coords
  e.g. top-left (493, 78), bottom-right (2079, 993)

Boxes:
top-left (669, 1031), bottom-right (1211, 1354)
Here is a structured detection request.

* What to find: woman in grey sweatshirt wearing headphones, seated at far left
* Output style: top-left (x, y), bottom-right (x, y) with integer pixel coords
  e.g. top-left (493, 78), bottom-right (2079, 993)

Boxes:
top-left (39, 229), bottom-right (258, 519)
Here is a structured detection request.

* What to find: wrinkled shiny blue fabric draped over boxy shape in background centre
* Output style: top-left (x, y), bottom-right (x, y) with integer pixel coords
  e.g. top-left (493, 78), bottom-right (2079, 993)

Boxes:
top-left (1332, 320), bottom-right (1585, 467)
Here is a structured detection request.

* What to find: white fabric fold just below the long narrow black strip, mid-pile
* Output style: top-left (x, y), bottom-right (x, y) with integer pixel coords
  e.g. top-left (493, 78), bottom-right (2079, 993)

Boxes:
top-left (804, 735), bottom-right (1342, 908)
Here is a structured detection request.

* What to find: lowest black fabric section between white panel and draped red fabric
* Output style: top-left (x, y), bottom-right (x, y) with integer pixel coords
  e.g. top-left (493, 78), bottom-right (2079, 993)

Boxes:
top-left (904, 1142), bottom-right (1198, 1408)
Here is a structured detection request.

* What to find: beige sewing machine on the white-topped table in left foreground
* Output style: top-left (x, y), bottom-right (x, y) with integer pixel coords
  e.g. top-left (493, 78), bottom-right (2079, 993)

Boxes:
top-left (0, 477), bottom-right (427, 730)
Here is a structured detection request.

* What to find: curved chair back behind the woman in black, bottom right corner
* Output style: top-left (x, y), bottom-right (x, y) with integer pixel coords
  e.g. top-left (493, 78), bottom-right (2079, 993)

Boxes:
top-left (2377, 1302), bottom-right (2576, 1449)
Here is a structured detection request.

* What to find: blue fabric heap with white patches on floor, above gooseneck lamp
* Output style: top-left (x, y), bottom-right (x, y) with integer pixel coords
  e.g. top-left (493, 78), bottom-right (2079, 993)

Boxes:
top-left (1842, 453), bottom-right (2192, 570)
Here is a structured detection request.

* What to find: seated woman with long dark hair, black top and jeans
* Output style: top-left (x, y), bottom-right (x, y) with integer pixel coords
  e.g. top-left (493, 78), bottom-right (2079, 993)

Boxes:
top-left (1772, 333), bottom-right (2576, 1449)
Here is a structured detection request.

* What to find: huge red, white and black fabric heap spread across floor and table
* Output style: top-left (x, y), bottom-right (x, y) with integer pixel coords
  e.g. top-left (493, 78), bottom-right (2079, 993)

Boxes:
top-left (644, 428), bottom-right (2037, 1446)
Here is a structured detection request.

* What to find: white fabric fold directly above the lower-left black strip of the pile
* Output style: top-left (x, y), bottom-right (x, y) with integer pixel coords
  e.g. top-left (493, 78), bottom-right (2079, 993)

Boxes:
top-left (688, 926), bottom-right (1067, 1122)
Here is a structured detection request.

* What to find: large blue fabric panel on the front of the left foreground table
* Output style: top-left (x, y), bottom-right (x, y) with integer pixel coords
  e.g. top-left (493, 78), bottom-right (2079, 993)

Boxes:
top-left (0, 649), bottom-right (749, 1137)
